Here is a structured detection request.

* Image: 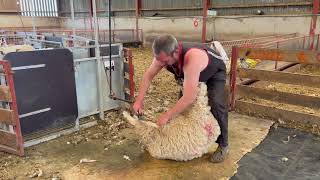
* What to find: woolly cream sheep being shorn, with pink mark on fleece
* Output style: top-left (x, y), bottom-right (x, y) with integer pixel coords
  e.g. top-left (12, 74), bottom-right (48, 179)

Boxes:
top-left (123, 83), bottom-right (220, 161)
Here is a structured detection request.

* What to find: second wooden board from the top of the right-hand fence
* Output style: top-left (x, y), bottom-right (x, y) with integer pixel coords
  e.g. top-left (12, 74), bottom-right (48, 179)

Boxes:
top-left (238, 68), bottom-right (320, 88)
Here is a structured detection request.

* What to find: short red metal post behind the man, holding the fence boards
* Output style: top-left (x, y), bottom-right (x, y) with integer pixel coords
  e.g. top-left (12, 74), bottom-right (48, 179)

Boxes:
top-left (229, 46), bottom-right (239, 111)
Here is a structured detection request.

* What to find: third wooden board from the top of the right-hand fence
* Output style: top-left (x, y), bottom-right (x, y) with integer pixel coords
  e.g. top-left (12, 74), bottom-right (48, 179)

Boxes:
top-left (236, 85), bottom-right (320, 108)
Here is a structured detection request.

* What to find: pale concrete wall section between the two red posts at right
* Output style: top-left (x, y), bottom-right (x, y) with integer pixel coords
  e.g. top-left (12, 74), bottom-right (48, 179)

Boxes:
top-left (208, 16), bottom-right (319, 39)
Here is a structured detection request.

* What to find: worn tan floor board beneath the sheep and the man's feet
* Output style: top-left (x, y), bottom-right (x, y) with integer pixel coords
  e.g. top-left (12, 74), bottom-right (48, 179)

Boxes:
top-left (62, 113), bottom-right (273, 180)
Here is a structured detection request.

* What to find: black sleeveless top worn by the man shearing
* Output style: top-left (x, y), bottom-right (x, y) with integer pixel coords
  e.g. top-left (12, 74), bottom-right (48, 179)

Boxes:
top-left (166, 43), bottom-right (226, 82)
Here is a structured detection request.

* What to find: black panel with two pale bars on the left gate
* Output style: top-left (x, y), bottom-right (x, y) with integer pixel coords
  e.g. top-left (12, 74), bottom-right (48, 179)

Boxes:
top-left (4, 49), bottom-right (78, 136)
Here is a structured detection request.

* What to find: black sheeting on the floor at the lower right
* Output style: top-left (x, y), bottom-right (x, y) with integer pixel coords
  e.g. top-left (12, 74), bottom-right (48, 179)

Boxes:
top-left (231, 128), bottom-right (320, 180)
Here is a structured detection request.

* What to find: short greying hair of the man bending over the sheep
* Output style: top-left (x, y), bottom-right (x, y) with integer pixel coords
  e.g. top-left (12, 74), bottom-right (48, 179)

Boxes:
top-left (152, 34), bottom-right (178, 55)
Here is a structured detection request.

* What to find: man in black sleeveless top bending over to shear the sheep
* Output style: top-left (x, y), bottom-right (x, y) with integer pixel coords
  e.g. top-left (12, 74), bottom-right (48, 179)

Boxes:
top-left (133, 35), bottom-right (229, 163)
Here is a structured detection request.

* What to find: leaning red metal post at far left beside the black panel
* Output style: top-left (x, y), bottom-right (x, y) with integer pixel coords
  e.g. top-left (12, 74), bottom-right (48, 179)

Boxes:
top-left (1, 61), bottom-right (24, 156)
